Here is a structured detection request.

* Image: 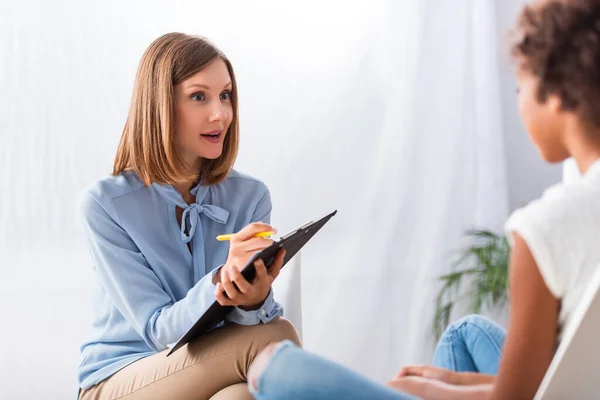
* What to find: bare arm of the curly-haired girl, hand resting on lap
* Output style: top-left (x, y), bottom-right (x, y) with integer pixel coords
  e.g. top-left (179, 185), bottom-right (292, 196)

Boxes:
top-left (388, 233), bottom-right (559, 400)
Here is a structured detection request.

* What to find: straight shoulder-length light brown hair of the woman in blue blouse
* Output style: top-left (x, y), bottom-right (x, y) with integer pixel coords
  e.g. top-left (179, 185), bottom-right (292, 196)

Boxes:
top-left (113, 33), bottom-right (239, 186)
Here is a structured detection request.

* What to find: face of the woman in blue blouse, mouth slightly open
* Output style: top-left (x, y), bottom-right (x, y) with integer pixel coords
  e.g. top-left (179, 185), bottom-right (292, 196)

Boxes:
top-left (175, 59), bottom-right (233, 169)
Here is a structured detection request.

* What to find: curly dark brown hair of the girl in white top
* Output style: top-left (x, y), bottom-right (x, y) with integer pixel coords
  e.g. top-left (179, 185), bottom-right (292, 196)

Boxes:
top-left (511, 0), bottom-right (600, 127)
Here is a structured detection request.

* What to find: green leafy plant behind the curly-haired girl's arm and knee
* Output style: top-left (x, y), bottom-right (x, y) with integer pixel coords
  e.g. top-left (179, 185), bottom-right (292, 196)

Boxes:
top-left (433, 230), bottom-right (510, 339)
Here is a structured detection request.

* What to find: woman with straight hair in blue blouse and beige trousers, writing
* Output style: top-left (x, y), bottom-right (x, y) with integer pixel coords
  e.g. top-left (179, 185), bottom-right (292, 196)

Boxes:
top-left (79, 33), bottom-right (299, 400)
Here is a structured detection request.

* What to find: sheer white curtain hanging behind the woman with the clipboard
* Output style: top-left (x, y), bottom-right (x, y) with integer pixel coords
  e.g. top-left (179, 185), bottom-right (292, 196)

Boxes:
top-left (0, 0), bottom-right (507, 399)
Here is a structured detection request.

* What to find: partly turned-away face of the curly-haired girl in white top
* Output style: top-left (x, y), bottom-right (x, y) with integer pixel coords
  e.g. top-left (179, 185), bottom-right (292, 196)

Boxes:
top-left (517, 71), bottom-right (569, 163)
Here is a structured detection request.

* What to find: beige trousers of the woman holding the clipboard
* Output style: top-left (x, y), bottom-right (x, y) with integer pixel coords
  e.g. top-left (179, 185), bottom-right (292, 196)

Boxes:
top-left (79, 318), bottom-right (300, 400)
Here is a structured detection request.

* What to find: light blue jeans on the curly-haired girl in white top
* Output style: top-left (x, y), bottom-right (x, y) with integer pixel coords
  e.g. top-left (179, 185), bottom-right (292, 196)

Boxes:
top-left (250, 316), bottom-right (505, 400)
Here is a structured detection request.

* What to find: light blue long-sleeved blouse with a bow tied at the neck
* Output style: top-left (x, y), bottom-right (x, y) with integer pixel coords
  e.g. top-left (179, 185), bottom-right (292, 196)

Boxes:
top-left (78, 171), bottom-right (282, 389)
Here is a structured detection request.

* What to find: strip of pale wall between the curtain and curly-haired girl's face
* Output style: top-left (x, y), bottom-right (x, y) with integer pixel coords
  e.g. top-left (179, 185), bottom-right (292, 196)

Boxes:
top-left (496, 0), bottom-right (562, 210)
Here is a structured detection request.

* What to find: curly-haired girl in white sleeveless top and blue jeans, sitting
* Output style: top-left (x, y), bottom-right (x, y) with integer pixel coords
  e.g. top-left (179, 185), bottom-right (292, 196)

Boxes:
top-left (250, 0), bottom-right (600, 400)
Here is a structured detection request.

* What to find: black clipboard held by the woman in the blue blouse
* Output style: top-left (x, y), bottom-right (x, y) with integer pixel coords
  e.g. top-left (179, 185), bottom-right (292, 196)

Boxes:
top-left (167, 210), bottom-right (337, 357)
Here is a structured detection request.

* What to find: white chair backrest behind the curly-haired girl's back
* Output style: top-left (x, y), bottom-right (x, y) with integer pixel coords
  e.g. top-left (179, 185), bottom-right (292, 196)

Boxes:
top-left (535, 266), bottom-right (600, 400)
